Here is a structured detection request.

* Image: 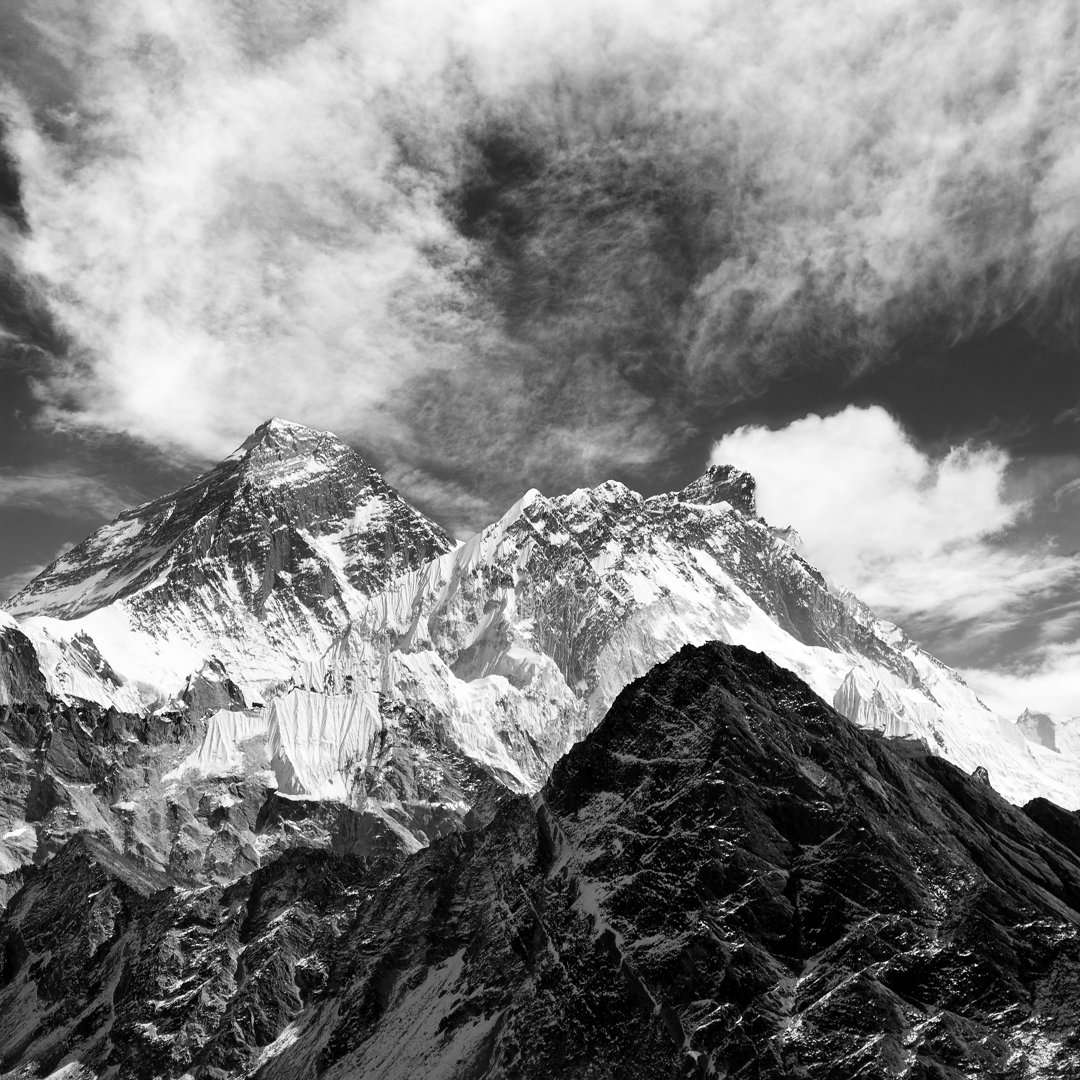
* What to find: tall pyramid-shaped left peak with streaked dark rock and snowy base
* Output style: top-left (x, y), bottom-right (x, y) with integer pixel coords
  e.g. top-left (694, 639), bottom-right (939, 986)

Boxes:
top-left (8, 419), bottom-right (451, 687)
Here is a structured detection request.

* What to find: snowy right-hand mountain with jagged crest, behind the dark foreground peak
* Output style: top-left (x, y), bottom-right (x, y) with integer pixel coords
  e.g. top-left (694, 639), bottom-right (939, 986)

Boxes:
top-left (317, 467), bottom-right (1080, 806)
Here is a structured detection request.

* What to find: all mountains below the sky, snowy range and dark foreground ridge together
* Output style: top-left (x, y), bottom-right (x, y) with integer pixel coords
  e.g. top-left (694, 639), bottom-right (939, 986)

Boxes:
top-left (0, 419), bottom-right (1080, 1080)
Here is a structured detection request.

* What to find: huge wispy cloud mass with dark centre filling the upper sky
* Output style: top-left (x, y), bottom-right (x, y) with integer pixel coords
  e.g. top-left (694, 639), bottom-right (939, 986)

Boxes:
top-left (2, 0), bottom-right (1080, 516)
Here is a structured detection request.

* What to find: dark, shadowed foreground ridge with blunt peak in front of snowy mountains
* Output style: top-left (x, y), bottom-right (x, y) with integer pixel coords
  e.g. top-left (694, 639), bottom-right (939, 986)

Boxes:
top-left (0, 644), bottom-right (1080, 1080)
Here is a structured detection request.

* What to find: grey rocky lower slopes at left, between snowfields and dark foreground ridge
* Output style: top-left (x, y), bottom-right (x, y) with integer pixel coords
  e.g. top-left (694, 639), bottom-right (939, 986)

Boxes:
top-left (0, 686), bottom-right (503, 912)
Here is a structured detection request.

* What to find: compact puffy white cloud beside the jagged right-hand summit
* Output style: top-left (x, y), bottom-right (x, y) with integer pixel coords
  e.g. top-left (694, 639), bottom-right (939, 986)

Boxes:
top-left (713, 406), bottom-right (1080, 666)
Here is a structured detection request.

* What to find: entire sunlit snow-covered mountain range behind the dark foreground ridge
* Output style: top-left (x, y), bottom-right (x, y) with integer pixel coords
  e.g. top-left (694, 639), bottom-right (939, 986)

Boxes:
top-left (0, 420), bottom-right (1080, 891)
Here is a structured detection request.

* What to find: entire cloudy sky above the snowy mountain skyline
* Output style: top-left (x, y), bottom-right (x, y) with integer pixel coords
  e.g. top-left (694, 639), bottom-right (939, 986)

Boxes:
top-left (0, 0), bottom-right (1080, 715)
